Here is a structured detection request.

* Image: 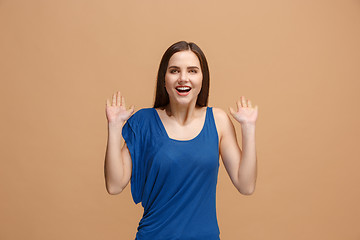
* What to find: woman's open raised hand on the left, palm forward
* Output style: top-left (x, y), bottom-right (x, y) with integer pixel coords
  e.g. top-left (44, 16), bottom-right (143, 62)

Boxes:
top-left (106, 91), bottom-right (134, 127)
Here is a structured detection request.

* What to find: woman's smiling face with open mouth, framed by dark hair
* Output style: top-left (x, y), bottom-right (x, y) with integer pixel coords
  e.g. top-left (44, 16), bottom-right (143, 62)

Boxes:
top-left (165, 50), bottom-right (203, 105)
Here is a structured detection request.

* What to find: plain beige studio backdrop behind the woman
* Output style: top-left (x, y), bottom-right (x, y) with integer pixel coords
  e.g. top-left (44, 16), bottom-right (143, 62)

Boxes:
top-left (0, 0), bottom-right (360, 240)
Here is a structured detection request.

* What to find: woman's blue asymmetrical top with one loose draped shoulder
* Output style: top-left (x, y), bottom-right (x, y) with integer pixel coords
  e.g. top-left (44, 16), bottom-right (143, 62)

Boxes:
top-left (122, 107), bottom-right (220, 240)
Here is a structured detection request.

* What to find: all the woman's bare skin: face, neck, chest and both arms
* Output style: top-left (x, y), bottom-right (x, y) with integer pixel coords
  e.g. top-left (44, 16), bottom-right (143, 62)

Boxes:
top-left (105, 51), bottom-right (258, 195)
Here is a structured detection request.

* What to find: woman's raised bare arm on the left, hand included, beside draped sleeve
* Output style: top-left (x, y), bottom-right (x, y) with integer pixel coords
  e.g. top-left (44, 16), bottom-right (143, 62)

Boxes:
top-left (104, 92), bottom-right (134, 195)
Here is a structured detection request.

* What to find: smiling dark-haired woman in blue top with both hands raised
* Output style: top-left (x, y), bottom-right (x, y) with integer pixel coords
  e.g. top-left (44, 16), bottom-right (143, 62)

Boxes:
top-left (105, 41), bottom-right (258, 240)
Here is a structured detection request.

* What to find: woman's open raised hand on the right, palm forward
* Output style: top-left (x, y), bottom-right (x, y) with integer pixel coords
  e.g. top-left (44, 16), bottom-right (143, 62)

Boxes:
top-left (229, 96), bottom-right (258, 125)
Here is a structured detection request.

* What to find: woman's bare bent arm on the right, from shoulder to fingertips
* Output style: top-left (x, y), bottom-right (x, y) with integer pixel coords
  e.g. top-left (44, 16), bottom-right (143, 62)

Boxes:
top-left (215, 96), bottom-right (258, 195)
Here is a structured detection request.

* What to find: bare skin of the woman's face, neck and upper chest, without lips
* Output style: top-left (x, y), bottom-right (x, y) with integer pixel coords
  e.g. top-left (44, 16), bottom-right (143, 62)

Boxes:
top-left (156, 51), bottom-right (206, 140)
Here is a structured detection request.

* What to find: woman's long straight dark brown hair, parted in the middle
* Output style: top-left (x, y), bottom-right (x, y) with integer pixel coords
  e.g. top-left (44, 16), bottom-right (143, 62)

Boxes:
top-left (154, 41), bottom-right (210, 108)
